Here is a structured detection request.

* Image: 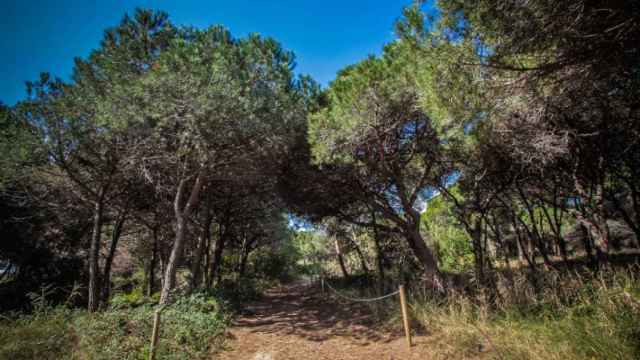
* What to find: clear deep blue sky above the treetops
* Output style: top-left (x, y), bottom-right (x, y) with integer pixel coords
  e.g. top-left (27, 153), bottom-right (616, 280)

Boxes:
top-left (0, 0), bottom-right (436, 105)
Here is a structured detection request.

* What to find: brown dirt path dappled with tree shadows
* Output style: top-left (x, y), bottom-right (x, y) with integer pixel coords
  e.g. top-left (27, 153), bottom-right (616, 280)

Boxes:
top-left (217, 285), bottom-right (430, 360)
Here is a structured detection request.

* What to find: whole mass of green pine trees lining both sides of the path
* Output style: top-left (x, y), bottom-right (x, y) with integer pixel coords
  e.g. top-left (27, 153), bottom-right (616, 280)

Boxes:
top-left (0, 0), bottom-right (640, 355)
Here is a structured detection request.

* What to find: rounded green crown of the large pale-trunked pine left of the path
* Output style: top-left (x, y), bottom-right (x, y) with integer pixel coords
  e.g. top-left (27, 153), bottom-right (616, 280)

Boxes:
top-left (104, 26), bottom-right (304, 169)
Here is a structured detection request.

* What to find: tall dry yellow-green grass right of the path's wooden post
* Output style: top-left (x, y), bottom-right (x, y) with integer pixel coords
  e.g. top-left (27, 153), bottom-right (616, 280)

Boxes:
top-left (411, 269), bottom-right (640, 360)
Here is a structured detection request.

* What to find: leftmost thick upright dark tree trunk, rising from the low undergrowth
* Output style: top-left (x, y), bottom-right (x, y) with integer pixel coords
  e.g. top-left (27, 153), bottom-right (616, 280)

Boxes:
top-left (88, 187), bottom-right (105, 312)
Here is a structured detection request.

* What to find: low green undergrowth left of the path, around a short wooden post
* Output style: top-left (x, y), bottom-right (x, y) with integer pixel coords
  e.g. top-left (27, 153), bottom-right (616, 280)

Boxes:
top-left (0, 294), bottom-right (229, 359)
